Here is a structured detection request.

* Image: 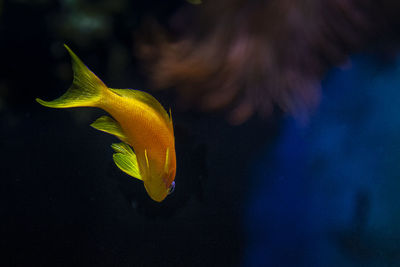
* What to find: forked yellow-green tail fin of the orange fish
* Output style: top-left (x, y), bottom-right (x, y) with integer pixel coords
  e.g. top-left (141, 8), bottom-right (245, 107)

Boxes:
top-left (36, 44), bottom-right (107, 108)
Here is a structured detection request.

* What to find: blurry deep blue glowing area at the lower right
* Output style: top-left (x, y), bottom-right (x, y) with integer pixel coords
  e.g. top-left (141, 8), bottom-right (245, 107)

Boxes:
top-left (244, 56), bottom-right (400, 266)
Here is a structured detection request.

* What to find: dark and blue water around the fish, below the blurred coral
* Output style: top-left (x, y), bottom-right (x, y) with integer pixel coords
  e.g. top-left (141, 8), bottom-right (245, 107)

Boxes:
top-left (0, 1), bottom-right (400, 266)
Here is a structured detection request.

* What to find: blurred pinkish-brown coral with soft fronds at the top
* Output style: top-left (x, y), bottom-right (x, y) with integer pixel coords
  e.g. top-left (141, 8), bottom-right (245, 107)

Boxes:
top-left (138, 0), bottom-right (384, 123)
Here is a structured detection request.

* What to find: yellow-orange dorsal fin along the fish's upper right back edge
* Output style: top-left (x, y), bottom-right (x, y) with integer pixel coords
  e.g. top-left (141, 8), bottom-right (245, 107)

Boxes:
top-left (110, 88), bottom-right (173, 130)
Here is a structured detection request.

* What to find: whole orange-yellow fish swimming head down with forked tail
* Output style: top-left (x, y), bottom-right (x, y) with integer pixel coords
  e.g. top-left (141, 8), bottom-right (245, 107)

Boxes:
top-left (36, 44), bottom-right (176, 202)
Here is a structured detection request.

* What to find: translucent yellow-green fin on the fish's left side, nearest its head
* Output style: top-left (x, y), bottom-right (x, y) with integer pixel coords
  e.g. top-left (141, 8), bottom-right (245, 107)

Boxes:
top-left (111, 143), bottom-right (143, 180)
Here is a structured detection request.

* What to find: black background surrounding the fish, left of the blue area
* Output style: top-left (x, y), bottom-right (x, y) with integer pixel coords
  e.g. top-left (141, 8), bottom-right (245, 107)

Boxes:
top-left (0, 1), bottom-right (274, 266)
